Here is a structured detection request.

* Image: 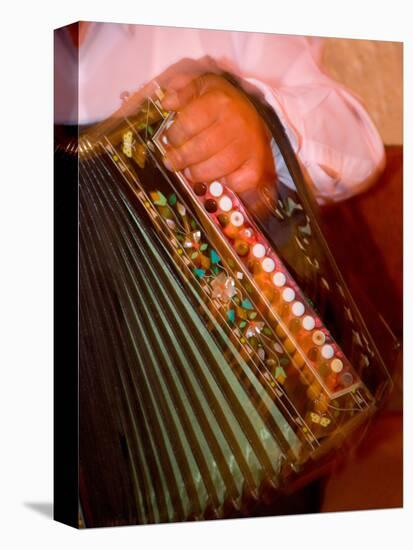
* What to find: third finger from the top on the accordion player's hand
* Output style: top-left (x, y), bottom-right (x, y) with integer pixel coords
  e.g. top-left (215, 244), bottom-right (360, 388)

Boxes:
top-left (164, 123), bottom-right (232, 170)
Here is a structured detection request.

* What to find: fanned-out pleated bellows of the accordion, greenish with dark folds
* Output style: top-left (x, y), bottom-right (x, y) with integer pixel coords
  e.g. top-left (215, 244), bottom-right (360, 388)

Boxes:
top-left (80, 153), bottom-right (299, 522)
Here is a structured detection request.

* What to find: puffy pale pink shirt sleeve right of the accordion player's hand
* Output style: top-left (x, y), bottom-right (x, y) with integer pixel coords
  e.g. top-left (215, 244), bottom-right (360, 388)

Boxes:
top-left (225, 39), bottom-right (385, 203)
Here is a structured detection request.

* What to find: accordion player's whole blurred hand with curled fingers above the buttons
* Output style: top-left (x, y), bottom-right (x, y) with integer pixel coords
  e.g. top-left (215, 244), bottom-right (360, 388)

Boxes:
top-left (162, 74), bottom-right (275, 192)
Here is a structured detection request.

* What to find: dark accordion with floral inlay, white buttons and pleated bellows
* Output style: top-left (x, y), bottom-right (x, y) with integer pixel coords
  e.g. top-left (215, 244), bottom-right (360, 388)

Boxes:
top-left (55, 80), bottom-right (391, 526)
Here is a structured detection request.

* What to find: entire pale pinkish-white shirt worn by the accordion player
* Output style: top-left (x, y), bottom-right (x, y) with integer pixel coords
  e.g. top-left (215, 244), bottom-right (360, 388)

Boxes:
top-left (55, 23), bottom-right (384, 202)
